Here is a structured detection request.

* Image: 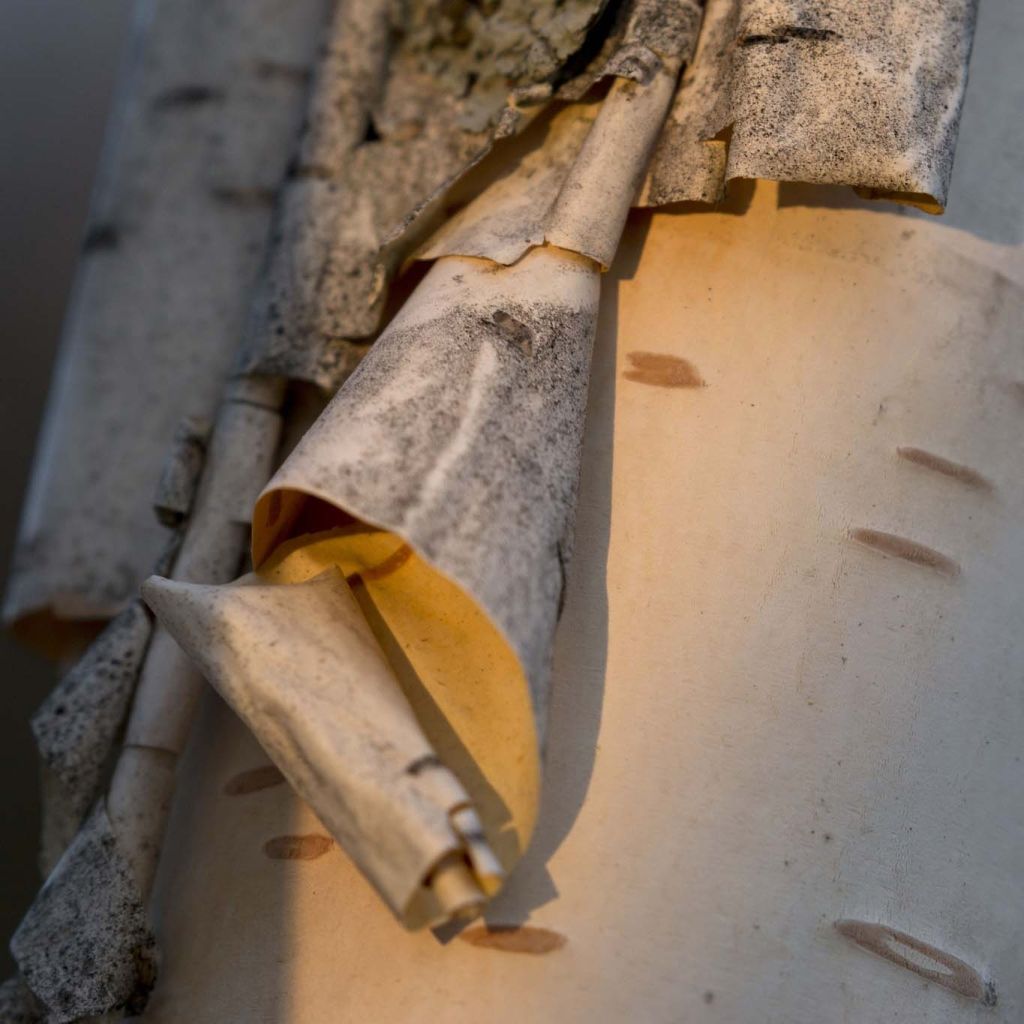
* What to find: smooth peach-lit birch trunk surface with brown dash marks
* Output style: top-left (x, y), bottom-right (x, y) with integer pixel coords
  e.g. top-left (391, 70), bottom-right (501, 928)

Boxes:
top-left (140, 3), bottom-right (1024, 1024)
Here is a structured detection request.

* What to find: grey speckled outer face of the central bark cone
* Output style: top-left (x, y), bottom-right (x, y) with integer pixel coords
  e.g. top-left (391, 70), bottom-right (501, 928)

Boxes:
top-left (255, 249), bottom-right (599, 735)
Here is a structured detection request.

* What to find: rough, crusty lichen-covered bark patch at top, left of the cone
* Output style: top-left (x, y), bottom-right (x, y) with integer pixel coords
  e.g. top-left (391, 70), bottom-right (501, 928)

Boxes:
top-left (239, 0), bottom-right (603, 391)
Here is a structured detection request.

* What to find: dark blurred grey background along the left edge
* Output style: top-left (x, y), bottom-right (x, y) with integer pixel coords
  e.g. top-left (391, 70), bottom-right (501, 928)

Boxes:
top-left (0, 0), bottom-right (131, 980)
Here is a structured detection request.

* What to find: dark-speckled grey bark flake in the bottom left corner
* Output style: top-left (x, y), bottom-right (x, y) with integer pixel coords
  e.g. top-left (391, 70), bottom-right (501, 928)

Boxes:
top-left (10, 804), bottom-right (157, 1024)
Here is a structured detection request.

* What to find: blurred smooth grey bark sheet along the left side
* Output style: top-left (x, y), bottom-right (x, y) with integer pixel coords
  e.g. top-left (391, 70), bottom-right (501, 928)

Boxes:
top-left (4, 0), bottom-right (325, 647)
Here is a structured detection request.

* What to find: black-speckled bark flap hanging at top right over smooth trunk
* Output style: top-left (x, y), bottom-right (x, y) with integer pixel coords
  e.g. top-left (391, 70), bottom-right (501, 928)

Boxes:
top-left (643, 0), bottom-right (977, 212)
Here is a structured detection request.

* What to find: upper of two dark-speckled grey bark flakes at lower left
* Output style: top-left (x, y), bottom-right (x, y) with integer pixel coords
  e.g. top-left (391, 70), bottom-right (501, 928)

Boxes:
top-left (32, 601), bottom-right (153, 865)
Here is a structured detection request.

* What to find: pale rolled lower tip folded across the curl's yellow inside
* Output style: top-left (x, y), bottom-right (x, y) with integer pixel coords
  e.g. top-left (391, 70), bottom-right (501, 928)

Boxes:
top-left (143, 569), bottom-right (503, 925)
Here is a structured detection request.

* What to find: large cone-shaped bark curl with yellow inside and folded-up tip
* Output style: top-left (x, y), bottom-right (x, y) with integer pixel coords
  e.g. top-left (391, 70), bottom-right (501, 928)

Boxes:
top-left (179, 241), bottom-right (599, 927)
